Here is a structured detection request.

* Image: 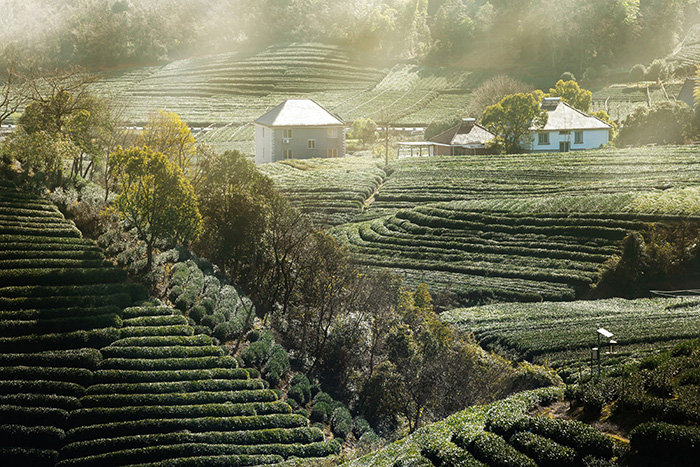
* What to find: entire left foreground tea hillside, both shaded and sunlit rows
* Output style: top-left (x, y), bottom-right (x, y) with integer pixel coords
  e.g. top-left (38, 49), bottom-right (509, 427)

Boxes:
top-left (0, 181), bottom-right (340, 466)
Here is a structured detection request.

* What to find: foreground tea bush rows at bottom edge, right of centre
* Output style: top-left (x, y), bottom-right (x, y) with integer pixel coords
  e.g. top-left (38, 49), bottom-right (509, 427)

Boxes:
top-left (345, 388), bottom-right (627, 467)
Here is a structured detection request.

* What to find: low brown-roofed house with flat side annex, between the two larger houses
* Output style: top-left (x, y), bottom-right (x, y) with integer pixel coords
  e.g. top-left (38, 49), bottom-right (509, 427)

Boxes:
top-left (398, 118), bottom-right (496, 157)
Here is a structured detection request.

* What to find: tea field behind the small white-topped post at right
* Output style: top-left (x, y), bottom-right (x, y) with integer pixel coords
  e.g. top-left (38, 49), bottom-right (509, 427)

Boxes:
top-left (440, 298), bottom-right (700, 381)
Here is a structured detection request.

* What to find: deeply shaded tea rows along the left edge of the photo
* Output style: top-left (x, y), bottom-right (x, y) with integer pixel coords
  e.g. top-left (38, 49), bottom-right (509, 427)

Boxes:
top-left (0, 184), bottom-right (146, 466)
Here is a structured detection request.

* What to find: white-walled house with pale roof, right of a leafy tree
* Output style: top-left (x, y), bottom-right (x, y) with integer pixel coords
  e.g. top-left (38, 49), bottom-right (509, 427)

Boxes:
top-left (525, 97), bottom-right (612, 152)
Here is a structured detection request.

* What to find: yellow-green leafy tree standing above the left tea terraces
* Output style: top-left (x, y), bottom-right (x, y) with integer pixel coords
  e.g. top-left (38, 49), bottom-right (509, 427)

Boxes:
top-left (109, 147), bottom-right (202, 271)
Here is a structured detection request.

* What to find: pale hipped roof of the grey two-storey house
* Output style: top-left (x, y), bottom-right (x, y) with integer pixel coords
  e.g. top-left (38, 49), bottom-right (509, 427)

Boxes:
top-left (255, 99), bottom-right (345, 127)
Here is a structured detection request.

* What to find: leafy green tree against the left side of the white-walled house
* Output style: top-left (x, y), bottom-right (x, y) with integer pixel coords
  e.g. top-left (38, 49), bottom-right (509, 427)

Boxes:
top-left (481, 93), bottom-right (547, 154)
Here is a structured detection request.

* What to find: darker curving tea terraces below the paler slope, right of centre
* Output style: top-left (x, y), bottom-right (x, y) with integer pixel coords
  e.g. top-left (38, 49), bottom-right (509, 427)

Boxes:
top-left (335, 202), bottom-right (643, 302)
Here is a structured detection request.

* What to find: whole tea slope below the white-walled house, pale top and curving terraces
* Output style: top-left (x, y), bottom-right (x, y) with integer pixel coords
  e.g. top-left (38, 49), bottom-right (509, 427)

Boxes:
top-left (324, 147), bottom-right (700, 303)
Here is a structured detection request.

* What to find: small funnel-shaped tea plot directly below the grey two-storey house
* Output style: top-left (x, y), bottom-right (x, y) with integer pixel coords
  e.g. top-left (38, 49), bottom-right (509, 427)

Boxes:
top-left (260, 157), bottom-right (386, 226)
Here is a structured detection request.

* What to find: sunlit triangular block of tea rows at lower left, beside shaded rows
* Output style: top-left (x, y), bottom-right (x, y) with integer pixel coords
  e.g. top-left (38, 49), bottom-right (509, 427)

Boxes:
top-left (59, 302), bottom-right (340, 466)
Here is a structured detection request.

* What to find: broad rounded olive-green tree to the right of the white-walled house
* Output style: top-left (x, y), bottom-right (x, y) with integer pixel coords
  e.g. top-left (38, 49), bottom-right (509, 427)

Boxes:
top-left (617, 101), bottom-right (693, 146)
